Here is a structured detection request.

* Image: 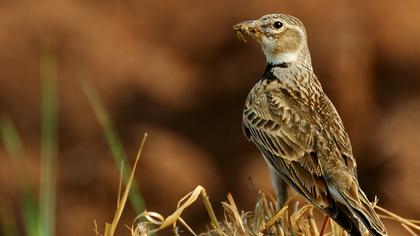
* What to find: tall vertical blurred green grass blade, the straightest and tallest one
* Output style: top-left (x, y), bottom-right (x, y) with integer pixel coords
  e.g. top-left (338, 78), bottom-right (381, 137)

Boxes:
top-left (40, 43), bottom-right (58, 236)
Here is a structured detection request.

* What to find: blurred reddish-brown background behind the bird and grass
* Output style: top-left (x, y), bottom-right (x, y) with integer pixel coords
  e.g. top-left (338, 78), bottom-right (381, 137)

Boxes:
top-left (0, 0), bottom-right (420, 235)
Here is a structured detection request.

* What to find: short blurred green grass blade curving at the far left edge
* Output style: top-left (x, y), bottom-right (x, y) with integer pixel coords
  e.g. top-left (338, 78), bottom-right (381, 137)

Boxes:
top-left (0, 119), bottom-right (39, 236)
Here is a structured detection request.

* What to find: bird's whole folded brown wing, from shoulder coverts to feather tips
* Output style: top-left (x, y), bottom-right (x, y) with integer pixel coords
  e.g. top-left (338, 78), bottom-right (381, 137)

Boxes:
top-left (243, 87), bottom-right (331, 208)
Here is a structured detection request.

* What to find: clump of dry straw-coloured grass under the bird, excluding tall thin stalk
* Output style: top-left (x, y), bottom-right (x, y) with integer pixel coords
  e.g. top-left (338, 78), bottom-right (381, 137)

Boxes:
top-left (131, 189), bottom-right (420, 236)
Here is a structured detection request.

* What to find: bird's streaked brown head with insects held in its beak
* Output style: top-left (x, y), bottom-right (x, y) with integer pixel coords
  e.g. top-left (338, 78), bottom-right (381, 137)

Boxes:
top-left (233, 14), bottom-right (309, 64)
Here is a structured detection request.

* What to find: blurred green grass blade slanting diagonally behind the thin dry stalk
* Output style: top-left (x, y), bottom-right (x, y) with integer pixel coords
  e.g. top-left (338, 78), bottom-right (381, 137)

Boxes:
top-left (82, 82), bottom-right (144, 214)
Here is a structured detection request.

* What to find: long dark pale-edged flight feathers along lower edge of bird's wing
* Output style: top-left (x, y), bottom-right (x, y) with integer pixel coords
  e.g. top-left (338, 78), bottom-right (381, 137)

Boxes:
top-left (244, 109), bottom-right (329, 208)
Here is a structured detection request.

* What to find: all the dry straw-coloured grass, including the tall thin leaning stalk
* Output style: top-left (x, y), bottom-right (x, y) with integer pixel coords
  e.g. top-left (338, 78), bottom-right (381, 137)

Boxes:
top-left (95, 135), bottom-right (420, 236)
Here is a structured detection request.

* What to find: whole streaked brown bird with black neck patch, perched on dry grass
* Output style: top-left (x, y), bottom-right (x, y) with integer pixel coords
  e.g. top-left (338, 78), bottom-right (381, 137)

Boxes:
top-left (233, 14), bottom-right (387, 236)
